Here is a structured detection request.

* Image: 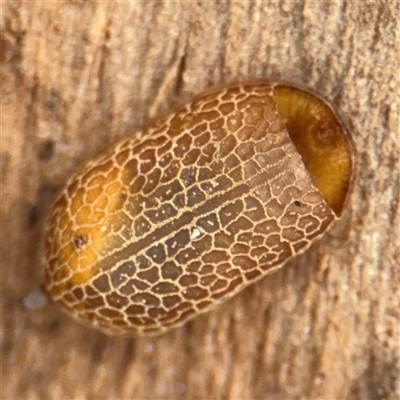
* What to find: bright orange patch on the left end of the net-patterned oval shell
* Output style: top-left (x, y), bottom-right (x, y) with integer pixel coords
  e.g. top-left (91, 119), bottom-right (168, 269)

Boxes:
top-left (45, 167), bottom-right (130, 297)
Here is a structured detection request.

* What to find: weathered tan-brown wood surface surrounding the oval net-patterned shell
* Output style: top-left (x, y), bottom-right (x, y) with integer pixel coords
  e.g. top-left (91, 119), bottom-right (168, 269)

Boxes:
top-left (0, 1), bottom-right (400, 400)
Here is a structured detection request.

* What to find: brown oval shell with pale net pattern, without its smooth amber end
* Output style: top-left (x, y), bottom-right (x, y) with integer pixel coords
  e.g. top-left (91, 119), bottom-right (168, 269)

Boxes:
top-left (44, 84), bottom-right (351, 336)
